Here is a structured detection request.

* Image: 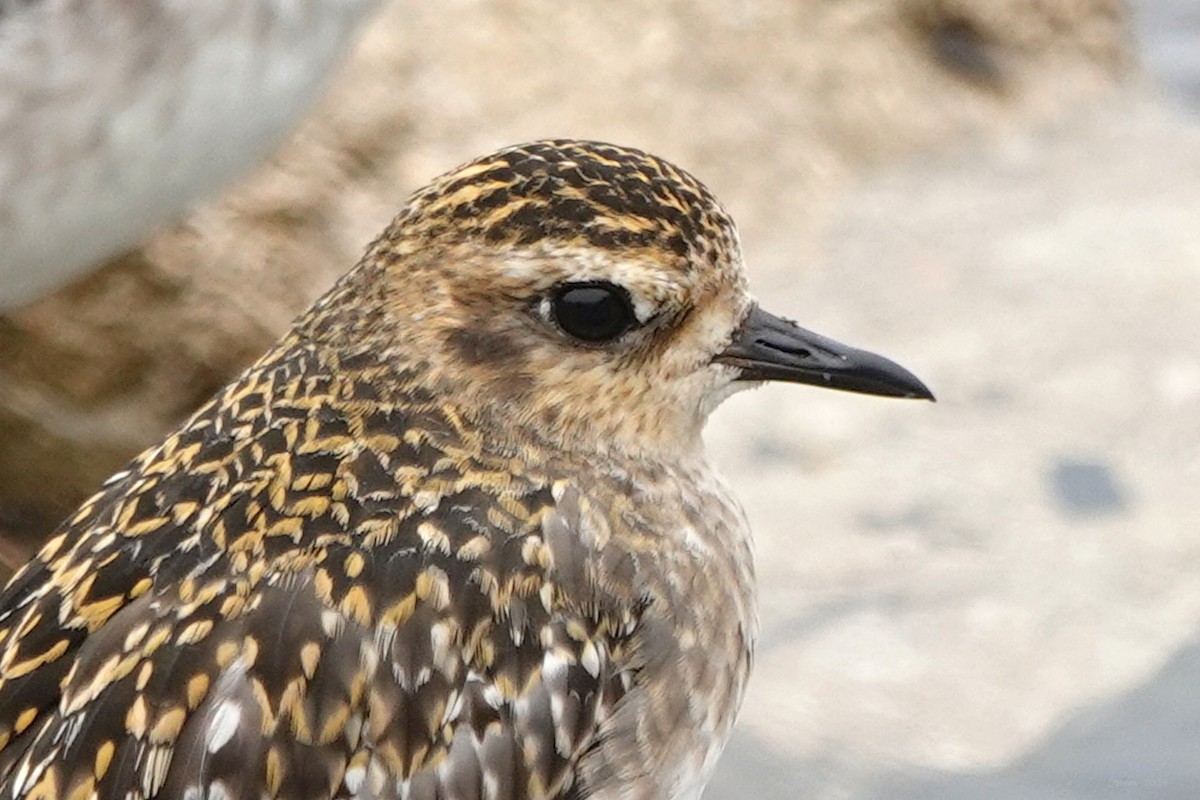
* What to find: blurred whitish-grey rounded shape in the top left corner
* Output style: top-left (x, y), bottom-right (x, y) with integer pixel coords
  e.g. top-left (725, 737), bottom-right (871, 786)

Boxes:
top-left (0, 0), bottom-right (376, 311)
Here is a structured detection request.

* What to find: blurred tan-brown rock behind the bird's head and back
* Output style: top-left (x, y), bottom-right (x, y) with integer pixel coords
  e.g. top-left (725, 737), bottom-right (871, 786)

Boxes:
top-left (0, 0), bottom-right (1130, 551)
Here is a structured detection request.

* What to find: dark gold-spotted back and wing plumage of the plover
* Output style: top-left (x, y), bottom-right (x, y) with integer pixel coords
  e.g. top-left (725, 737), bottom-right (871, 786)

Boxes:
top-left (0, 378), bottom-right (632, 800)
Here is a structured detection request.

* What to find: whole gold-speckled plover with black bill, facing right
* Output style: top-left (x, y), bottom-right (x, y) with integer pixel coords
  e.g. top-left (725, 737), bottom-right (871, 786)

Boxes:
top-left (0, 140), bottom-right (931, 800)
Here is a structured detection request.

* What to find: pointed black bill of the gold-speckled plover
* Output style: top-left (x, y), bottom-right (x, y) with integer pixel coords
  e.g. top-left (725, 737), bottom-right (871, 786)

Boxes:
top-left (714, 306), bottom-right (935, 401)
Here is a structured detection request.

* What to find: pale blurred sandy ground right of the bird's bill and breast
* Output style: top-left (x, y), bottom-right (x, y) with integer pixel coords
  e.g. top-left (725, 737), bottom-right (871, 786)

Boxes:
top-left (706, 37), bottom-right (1200, 800)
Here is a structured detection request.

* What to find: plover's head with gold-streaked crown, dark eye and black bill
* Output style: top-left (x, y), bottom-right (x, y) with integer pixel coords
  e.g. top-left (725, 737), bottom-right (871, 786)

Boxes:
top-left (307, 140), bottom-right (932, 460)
